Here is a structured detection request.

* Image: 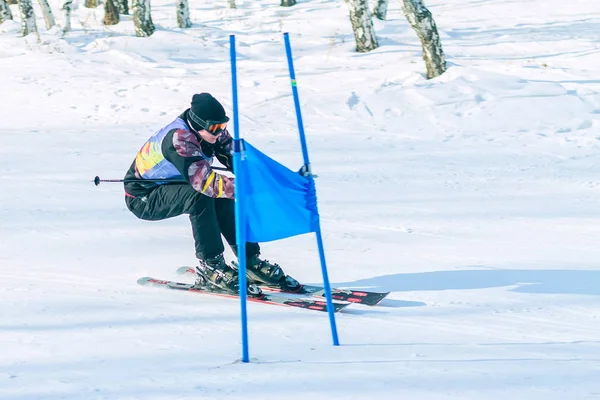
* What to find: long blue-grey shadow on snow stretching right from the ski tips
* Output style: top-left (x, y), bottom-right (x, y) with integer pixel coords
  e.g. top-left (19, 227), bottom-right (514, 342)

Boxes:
top-left (335, 266), bottom-right (600, 295)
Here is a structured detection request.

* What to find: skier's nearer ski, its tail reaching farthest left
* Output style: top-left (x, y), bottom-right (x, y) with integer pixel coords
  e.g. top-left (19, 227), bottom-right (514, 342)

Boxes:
top-left (137, 277), bottom-right (350, 312)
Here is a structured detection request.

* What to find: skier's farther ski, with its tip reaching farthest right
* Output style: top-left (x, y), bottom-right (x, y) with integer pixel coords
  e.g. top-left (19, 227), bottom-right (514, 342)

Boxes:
top-left (177, 267), bottom-right (390, 306)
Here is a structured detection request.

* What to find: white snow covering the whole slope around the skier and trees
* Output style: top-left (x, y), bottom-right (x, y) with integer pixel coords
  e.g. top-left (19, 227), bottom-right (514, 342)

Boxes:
top-left (0, 0), bottom-right (600, 400)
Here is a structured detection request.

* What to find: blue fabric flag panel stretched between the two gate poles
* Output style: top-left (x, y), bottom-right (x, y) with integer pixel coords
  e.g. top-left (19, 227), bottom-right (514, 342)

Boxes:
top-left (237, 140), bottom-right (319, 242)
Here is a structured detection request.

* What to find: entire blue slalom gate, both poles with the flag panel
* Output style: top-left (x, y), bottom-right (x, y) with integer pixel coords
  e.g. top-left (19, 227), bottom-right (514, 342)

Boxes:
top-left (229, 33), bottom-right (340, 363)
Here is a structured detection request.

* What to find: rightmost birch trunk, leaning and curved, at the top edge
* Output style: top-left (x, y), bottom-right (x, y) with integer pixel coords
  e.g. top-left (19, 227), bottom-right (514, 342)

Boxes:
top-left (402, 0), bottom-right (446, 79)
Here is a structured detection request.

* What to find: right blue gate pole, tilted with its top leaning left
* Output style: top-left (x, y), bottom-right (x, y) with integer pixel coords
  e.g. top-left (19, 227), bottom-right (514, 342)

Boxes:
top-left (283, 32), bottom-right (340, 346)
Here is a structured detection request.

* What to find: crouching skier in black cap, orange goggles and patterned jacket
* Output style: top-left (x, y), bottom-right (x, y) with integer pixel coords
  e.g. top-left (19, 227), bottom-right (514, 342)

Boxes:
top-left (125, 93), bottom-right (301, 294)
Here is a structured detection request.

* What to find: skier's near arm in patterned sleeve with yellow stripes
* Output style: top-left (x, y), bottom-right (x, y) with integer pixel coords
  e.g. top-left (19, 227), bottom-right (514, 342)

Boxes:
top-left (163, 129), bottom-right (234, 199)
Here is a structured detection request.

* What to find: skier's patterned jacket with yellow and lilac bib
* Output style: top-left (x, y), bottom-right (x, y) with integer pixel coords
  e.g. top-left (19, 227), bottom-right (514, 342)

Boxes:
top-left (124, 110), bottom-right (234, 199)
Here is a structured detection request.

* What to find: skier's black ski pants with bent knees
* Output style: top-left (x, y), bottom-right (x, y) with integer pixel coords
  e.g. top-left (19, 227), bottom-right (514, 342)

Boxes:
top-left (125, 183), bottom-right (260, 260)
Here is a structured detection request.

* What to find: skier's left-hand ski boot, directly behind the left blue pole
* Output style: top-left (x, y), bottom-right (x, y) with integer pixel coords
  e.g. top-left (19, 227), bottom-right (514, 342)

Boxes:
top-left (195, 254), bottom-right (262, 297)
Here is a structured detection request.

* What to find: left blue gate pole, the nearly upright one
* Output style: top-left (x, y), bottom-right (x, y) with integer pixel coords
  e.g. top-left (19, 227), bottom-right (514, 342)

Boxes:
top-left (229, 35), bottom-right (250, 363)
